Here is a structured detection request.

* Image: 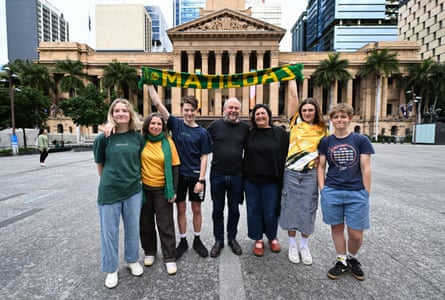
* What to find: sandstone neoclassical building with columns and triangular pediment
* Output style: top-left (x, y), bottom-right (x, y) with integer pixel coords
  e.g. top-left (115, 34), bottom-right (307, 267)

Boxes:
top-left (39, 0), bottom-right (419, 142)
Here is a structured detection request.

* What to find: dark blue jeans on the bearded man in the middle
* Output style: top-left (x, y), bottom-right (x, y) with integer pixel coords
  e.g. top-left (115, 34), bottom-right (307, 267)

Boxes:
top-left (210, 174), bottom-right (243, 242)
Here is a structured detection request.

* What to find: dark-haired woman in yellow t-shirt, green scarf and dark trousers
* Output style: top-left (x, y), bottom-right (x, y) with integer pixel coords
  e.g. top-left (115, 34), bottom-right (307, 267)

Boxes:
top-left (140, 113), bottom-right (180, 275)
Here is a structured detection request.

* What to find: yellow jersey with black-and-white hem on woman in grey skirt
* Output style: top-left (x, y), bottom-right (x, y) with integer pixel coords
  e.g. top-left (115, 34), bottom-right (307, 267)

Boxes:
top-left (286, 113), bottom-right (328, 171)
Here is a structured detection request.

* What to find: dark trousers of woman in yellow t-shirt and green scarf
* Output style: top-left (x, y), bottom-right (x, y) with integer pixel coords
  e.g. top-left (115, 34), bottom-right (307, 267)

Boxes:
top-left (140, 187), bottom-right (176, 262)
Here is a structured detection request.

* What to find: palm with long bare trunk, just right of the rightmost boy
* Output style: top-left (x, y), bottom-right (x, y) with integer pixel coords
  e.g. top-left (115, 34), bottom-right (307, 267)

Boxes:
top-left (359, 48), bottom-right (399, 141)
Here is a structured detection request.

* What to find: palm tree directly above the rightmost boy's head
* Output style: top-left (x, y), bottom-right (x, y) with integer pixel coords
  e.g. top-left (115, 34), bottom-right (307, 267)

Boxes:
top-left (312, 52), bottom-right (351, 129)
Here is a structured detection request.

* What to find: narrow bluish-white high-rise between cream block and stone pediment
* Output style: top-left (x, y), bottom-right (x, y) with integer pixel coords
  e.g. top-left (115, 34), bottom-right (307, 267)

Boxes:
top-left (145, 6), bottom-right (173, 52)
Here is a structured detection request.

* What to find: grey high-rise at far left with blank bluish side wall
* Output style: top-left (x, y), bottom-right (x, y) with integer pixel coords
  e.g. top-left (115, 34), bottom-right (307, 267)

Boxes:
top-left (5, 0), bottom-right (69, 61)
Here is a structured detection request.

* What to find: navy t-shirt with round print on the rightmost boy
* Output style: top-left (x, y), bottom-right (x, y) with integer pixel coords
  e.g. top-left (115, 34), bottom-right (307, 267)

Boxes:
top-left (318, 132), bottom-right (374, 190)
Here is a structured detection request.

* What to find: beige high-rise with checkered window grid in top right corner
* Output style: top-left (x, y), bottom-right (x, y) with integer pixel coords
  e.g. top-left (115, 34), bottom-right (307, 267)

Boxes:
top-left (399, 0), bottom-right (445, 63)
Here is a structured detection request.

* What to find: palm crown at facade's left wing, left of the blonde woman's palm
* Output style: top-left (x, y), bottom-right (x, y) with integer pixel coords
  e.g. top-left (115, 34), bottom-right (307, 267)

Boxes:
top-left (54, 59), bottom-right (88, 102)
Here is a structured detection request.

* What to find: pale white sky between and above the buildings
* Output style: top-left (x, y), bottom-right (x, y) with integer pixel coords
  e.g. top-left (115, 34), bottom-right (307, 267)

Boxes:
top-left (0, 0), bottom-right (307, 64)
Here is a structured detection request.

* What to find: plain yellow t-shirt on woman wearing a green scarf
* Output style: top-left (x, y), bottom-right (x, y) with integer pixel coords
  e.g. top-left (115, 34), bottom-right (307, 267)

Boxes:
top-left (141, 137), bottom-right (181, 187)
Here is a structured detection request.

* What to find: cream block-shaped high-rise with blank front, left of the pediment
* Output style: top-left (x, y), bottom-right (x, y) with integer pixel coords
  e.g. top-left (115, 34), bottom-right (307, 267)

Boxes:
top-left (96, 4), bottom-right (152, 52)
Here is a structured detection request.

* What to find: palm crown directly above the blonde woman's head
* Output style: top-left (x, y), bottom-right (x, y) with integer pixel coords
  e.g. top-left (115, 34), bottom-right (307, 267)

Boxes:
top-left (103, 60), bottom-right (138, 98)
